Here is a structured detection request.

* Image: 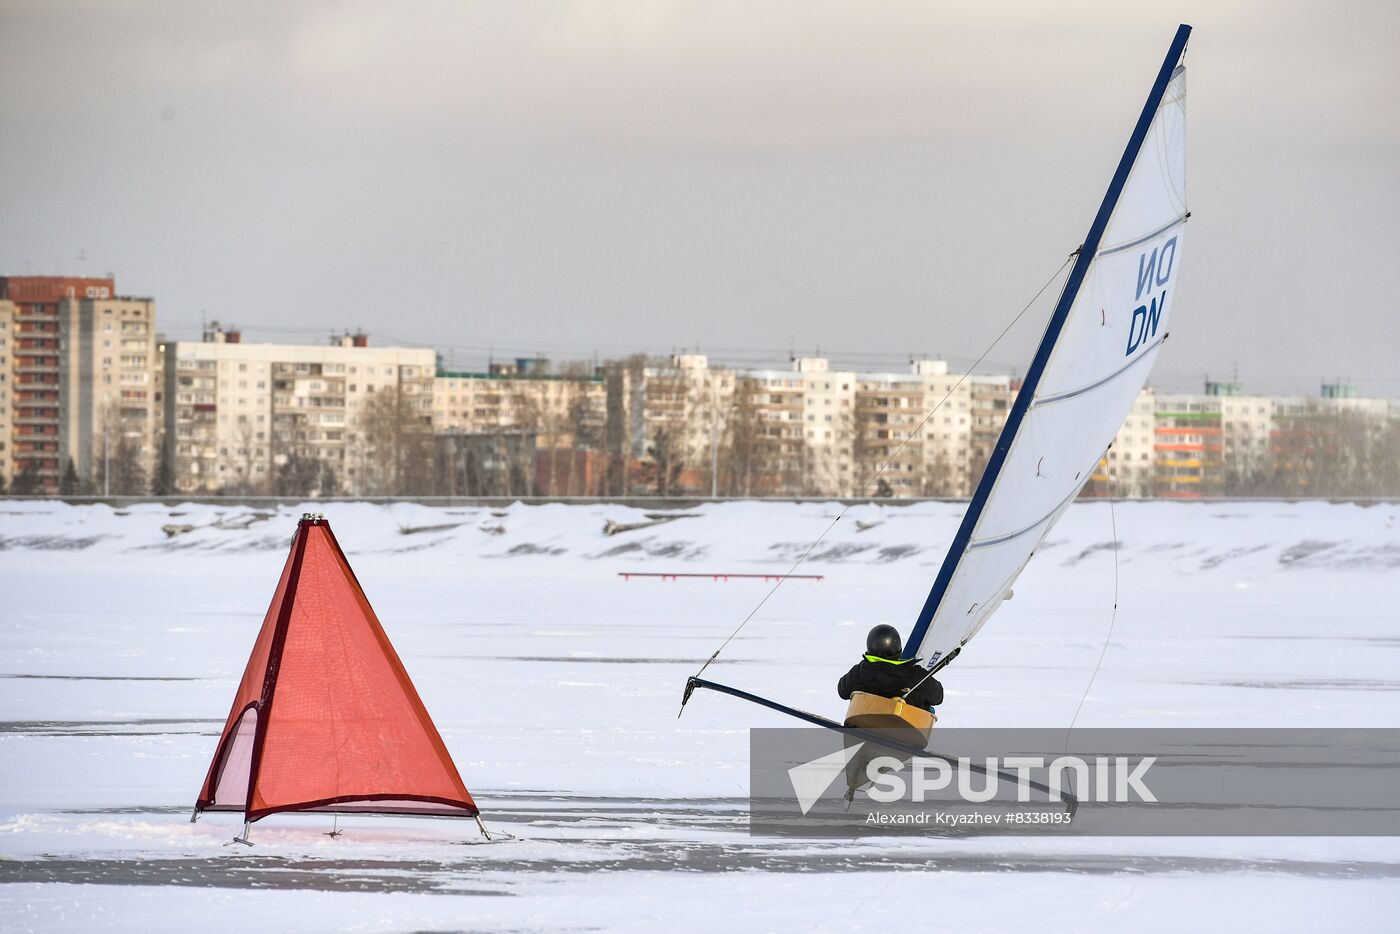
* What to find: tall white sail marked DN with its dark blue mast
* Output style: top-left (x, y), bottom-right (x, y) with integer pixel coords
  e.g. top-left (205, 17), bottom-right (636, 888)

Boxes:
top-left (904, 25), bottom-right (1191, 667)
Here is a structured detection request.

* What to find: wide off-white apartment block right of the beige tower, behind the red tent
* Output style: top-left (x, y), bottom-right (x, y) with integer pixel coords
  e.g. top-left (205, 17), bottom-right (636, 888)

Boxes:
top-left (164, 323), bottom-right (437, 496)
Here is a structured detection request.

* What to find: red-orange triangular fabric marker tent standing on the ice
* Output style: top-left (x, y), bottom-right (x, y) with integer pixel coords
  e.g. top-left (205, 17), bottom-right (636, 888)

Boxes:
top-left (195, 514), bottom-right (477, 823)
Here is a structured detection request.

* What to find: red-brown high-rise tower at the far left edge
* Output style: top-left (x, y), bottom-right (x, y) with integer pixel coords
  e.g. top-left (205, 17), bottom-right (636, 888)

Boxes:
top-left (0, 276), bottom-right (116, 493)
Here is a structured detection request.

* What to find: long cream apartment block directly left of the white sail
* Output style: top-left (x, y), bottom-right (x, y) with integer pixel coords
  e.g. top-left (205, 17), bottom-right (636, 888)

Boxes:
top-left (632, 354), bottom-right (1014, 496)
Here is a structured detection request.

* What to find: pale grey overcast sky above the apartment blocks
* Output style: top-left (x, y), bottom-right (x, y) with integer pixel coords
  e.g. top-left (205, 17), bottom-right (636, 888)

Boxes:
top-left (0, 0), bottom-right (1400, 396)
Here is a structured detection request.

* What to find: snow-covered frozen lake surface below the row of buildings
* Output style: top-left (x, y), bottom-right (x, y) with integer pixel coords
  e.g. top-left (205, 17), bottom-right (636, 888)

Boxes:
top-left (0, 500), bottom-right (1400, 931)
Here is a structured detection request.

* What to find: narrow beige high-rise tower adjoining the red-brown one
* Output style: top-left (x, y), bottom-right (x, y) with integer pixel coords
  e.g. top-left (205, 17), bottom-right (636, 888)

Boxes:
top-left (59, 297), bottom-right (162, 494)
